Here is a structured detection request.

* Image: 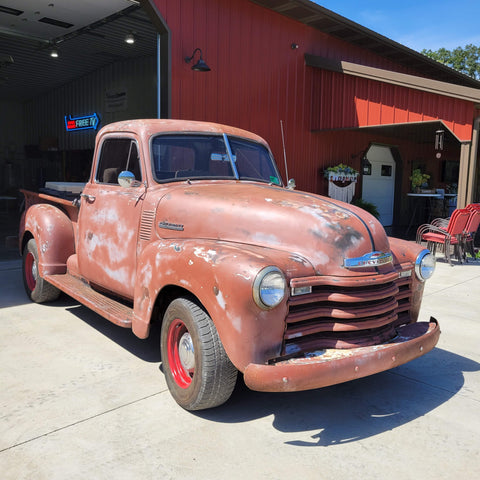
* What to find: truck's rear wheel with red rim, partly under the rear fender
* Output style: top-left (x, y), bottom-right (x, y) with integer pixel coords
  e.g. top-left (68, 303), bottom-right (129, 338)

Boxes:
top-left (22, 238), bottom-right (60, 303)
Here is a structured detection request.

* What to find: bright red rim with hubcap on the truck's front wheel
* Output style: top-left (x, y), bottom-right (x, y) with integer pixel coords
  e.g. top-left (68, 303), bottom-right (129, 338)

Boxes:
top-left (167, 319), bottom-right (195, 388)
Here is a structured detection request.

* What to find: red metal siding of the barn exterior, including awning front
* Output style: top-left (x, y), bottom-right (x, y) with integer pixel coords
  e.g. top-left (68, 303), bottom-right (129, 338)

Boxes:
top-left (153, 0), bottom-right (473, 193)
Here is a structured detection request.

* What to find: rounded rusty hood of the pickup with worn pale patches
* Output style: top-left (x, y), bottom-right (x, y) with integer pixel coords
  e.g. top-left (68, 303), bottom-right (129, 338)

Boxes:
top-left (156, 181), bottom-right (390, 276)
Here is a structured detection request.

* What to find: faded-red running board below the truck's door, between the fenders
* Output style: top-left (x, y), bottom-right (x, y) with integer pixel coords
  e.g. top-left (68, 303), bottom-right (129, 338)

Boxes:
top-left (45, 273), bottom-right (133, 328)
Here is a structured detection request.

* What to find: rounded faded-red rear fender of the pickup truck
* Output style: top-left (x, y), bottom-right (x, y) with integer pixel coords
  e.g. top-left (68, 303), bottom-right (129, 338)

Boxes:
top-left (21, 203), bottom-right (75, 277)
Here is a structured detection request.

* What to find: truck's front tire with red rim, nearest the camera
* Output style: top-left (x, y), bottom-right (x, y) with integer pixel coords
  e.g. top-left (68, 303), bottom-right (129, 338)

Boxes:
top-left (160, 298), bottom-right (237, 410)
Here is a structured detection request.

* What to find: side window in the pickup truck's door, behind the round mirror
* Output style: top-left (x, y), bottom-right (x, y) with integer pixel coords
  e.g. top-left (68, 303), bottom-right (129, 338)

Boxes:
top-left (95, 138), bottom-right (142, 185)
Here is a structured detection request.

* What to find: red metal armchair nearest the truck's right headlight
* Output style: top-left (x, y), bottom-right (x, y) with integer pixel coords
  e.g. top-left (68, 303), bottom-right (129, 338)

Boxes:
top-left (417, 208), bottom-right (471, 265)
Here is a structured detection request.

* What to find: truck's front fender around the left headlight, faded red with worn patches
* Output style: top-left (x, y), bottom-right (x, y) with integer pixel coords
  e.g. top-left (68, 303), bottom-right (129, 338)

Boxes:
top-left (132, 240), bottom-right (313, 371)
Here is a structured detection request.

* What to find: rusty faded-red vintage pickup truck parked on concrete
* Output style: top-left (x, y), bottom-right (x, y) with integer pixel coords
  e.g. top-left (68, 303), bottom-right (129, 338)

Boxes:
top-left (19, 119), bottom-right (440, 410)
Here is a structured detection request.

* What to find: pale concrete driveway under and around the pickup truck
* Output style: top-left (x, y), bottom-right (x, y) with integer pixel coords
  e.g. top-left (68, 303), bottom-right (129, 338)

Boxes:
top-left (0, 256), bottom-right (480, 480)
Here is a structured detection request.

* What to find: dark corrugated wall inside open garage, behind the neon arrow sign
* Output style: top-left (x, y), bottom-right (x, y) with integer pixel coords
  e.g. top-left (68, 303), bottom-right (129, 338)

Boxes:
top-left (25, 57), bottom-right (157, 150)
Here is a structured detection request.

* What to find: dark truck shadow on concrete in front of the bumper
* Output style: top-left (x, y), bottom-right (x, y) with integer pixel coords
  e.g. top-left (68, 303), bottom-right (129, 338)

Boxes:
top-left (196, 348), bottom-right (480, 447)
